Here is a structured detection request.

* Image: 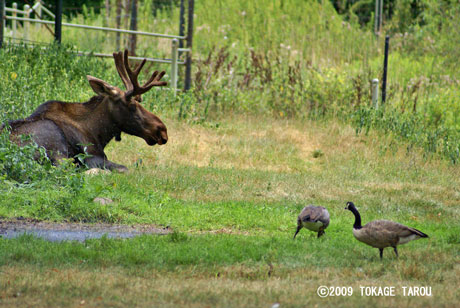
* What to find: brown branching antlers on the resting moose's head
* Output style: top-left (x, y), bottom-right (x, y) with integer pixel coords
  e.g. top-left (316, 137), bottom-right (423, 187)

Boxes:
top-left (113, 50), bottom-right (167, 99)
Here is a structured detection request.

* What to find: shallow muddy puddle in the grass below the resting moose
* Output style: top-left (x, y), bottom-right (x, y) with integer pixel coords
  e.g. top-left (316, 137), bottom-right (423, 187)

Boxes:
top-left (0, 219), bottom-right (171, 242)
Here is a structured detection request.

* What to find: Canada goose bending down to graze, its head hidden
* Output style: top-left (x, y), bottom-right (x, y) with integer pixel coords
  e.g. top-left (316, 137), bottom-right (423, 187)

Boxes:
top-left (294, 205), bottom-right (329, 239)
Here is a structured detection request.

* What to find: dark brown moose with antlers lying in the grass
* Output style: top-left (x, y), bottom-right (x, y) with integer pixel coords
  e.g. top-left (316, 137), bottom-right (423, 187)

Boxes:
top-left (2, 50), bottom-right (168, 172)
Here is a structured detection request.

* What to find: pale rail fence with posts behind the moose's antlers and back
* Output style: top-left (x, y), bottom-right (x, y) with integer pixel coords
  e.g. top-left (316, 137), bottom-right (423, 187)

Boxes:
top-left (0, 0), bottom-right (194, 91)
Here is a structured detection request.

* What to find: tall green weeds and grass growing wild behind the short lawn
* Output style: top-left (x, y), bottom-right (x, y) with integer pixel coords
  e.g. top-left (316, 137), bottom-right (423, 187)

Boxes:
top-left (0, 0), bottom-right (460, 166)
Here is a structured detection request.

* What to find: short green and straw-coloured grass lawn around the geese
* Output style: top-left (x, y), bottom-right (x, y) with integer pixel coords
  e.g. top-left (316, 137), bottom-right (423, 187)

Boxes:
top-left (0, 116), bottom-right (460, 307)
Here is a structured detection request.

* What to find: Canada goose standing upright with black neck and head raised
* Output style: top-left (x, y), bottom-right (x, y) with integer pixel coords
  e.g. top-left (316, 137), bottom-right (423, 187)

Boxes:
top-left (345, 202), bottom-right (428, 259)
